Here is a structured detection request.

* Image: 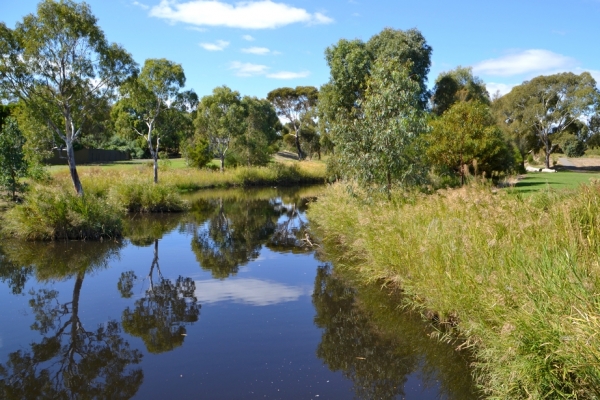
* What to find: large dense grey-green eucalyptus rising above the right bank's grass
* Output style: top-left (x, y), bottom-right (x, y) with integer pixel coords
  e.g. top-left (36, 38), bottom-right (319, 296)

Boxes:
top-left (318, 29), bottom-right (431, 194)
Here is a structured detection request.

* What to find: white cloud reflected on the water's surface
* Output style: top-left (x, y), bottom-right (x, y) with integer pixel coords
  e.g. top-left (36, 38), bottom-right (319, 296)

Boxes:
top-left (195, 279), bottom-right (306, 306)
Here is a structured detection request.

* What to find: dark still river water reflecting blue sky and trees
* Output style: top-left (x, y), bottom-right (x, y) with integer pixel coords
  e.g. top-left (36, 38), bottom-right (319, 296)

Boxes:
top-left (0, 188), bottom-right (475, 399)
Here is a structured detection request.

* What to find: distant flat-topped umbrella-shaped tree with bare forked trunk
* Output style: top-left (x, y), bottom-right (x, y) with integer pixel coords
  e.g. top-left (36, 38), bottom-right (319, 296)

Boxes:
top-left (267, 86), bottom-right (319, 160)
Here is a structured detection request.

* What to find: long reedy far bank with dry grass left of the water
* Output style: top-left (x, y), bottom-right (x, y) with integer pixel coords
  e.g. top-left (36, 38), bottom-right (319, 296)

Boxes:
top-left (0, 162), bottom-right (325, 240)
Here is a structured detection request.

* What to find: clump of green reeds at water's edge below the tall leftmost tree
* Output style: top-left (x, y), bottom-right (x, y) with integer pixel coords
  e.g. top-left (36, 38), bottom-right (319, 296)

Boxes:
top-left (3, 185), bottom-right (123, 240)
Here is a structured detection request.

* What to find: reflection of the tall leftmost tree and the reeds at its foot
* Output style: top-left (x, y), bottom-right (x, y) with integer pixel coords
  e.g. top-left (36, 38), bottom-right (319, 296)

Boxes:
top-left (0, 243), bottom-right (143, 399)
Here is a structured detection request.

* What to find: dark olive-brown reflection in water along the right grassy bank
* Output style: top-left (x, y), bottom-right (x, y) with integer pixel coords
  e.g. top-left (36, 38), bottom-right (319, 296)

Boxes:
top-left (313, 265), bottom-right (476, 399)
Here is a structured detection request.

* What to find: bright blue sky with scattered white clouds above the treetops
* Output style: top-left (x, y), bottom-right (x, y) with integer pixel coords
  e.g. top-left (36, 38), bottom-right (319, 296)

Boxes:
top-left (0, 0), bottom-right (600, 98)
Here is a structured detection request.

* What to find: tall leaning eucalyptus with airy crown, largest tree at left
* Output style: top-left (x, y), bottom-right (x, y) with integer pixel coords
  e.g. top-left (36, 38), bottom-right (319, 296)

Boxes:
top-left (0, 0), bottom-right (136, 195)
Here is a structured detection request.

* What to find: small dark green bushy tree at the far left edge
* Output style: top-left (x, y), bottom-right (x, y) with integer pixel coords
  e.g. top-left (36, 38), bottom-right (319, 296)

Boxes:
top-left (0, 117), bottom-right (28, 201)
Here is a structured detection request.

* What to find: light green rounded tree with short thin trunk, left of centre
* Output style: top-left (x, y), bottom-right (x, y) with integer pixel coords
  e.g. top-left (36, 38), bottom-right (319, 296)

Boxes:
top-left (194, 86), bottom-right (247, 172)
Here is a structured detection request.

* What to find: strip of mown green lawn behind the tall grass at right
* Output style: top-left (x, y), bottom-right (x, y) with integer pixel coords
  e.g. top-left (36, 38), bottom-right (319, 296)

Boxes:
top-left (510, 171), bottom-right (600, 194)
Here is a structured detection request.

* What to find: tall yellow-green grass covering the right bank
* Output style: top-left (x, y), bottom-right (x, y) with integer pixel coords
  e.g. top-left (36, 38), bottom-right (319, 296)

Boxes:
top-left (309, 185), bottom-right (600, 399)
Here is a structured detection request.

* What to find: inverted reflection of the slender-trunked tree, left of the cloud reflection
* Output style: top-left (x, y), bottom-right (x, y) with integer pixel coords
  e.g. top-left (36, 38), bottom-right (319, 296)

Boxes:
top-left (118, 239), bottom-right (200, 353)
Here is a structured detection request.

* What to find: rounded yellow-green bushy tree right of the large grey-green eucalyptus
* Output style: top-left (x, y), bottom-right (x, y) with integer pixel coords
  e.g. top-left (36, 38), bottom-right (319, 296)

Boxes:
top-left (426, 101), bottom-right (514, 183)
